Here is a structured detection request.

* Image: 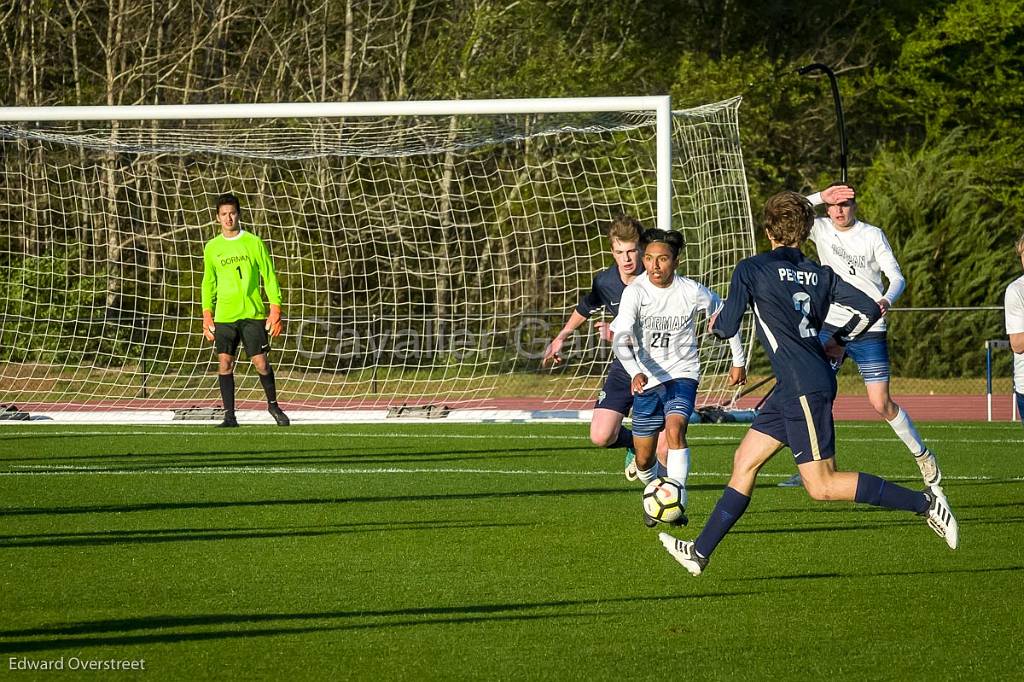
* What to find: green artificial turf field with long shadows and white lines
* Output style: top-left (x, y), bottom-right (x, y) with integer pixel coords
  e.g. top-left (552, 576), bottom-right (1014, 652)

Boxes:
top-left (0, 423), bottom-right (1024, 680)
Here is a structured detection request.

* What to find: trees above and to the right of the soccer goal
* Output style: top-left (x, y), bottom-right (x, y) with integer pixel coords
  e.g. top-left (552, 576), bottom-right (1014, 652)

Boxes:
top-left (0, 0), bottom-right (1024, 376)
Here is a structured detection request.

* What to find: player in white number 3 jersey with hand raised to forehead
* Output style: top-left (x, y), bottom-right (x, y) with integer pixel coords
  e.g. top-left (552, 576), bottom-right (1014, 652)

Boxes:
top-left (787, 183), bottom-right (942, 485)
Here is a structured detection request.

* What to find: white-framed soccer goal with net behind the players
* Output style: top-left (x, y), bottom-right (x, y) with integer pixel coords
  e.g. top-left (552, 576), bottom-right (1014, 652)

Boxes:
top-left (0, 97), bottom-right (754, 419)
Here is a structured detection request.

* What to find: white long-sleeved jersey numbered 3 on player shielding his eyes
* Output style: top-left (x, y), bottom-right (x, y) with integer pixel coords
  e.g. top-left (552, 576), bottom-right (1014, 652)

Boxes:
top-left (807, 195), bottom-right (906, 332)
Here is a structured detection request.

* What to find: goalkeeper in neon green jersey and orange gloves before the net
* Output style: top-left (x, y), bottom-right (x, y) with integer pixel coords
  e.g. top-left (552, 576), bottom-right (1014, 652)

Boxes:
top-left (203, 194), bottom-right (290, 426)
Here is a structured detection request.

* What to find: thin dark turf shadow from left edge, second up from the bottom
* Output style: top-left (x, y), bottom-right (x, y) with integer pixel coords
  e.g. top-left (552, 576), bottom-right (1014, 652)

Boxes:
top-left (0, 521), bottom-right (531, 551)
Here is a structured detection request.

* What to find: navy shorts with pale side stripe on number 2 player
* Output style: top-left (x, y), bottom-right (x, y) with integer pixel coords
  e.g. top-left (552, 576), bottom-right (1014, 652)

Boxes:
top-left (751, 393), bottom-right (836, 464)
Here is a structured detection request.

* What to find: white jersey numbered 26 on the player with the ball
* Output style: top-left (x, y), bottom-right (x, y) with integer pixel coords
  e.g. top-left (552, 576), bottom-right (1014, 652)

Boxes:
top-left (611, 272), bottom-right (746, 390)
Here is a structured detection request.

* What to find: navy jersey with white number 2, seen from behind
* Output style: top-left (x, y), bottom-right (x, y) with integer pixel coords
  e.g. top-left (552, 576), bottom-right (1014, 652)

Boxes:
top-left (712, 247), bottom-right (882, 398)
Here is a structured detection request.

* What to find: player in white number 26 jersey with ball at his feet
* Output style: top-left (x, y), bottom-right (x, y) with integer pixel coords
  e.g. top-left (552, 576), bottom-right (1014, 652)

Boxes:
top-left (611, 229), bottom-right (746, 525)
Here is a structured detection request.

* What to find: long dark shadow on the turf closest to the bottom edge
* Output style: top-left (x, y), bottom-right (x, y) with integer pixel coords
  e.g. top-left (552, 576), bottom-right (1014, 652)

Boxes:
top-left (0, 591), bottom-right (764, 653)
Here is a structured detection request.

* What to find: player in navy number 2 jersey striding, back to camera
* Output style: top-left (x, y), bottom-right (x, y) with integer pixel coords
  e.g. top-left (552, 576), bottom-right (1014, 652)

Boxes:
top-left (659, 191), bottom-right (958, 576)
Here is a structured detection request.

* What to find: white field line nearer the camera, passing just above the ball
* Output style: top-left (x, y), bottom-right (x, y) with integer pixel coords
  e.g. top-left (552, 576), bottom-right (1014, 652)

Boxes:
top-left (0, 464), bottom-right (1024, 481)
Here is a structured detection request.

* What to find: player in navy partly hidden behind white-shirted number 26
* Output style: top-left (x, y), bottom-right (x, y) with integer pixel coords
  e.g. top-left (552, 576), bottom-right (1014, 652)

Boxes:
top-left (541, 215), bottom-right (666, 480)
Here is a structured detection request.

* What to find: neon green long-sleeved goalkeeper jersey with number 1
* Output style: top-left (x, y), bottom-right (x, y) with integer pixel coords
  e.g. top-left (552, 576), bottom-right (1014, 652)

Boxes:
top-left (203, 229), bottom-right (281, 323)
